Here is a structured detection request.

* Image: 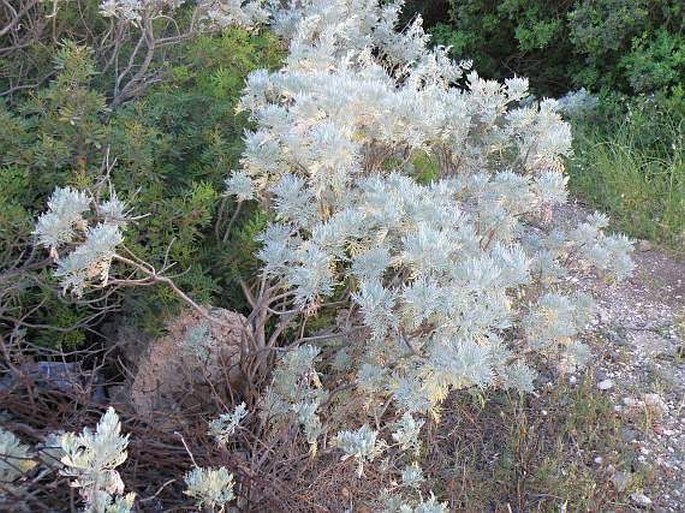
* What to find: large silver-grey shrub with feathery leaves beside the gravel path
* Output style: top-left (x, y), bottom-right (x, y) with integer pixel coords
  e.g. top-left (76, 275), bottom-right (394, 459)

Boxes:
top-left (36, 0), bottom-right (632, 506)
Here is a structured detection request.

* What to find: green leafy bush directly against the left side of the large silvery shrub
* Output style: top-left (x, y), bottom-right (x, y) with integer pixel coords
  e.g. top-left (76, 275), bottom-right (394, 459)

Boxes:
top-left (105, 29), bottom-right (280, 324)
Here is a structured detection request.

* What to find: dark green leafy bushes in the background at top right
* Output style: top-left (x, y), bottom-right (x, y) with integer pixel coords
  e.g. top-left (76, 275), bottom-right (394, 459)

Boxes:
top-left (411, 0), bottom-right (685, 96)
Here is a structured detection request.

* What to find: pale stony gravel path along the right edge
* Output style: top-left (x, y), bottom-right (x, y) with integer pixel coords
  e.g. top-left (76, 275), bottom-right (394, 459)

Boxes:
top-left (564, 205), bottom-right (685, 512)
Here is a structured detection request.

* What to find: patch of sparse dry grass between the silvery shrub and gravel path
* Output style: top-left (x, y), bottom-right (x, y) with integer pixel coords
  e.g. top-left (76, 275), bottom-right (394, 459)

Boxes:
top-left (426, 376), bottom-right (633, 513)
